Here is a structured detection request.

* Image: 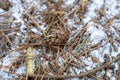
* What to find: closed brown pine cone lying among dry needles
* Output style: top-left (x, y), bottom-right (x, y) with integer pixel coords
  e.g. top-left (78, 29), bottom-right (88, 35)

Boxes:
top-left (41, 28), bottom-right (70, 46)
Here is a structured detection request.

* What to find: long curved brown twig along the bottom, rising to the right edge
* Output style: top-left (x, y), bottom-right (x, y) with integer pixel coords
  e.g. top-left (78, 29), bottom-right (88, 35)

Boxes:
top-left (23, 55), bottom-right (120, 79)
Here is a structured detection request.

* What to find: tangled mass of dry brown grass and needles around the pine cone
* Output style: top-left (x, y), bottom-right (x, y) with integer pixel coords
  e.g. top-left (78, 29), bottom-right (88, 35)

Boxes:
top-left (0, 0), bottom-right (120, 80)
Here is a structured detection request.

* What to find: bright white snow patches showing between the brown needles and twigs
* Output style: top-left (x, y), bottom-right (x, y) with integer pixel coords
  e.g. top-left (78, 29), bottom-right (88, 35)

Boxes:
top-left (0, 0), bottom-right (120, 80)
